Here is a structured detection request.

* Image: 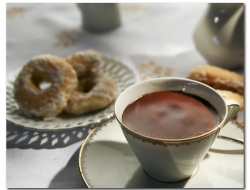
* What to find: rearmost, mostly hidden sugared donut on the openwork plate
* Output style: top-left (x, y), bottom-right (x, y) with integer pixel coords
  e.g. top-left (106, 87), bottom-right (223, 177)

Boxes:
top-left (65, 50), bottom-right (101, 77)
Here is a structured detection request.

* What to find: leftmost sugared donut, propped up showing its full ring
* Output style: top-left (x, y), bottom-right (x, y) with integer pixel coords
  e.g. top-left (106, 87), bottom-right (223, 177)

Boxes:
top-left (14, 55), bottom-right (77, 117)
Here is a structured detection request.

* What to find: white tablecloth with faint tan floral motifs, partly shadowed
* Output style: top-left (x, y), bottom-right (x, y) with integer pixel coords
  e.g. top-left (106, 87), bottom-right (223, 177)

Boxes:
top-left (6, 3), bottom-right (246, 188)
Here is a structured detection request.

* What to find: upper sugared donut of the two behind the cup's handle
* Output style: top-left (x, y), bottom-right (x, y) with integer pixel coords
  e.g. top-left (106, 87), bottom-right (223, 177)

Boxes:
top-left (187, 65), bottom-right (244, 94)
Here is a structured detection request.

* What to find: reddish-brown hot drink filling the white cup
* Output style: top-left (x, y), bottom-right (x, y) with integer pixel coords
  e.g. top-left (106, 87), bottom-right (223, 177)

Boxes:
top-left (122, 91), bottom-right (219, 139)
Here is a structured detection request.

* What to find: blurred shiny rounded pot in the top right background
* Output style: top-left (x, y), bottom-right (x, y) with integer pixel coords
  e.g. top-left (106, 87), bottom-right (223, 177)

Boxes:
top-left (193, 3), bottom-right (245, 69)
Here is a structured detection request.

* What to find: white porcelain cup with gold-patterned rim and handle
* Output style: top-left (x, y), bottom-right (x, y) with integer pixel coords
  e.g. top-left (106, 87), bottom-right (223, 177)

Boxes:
top-left (115, 77), bottom-right (239, 182)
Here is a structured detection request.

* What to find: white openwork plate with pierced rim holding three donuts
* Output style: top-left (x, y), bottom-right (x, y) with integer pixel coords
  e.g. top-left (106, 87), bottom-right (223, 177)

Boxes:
top-left (6, 56), bottom-right (137, 130)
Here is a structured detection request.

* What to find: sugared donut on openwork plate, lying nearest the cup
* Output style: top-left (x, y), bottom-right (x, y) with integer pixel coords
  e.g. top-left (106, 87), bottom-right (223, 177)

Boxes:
top-left (65, 72), bottom-right (118, 115)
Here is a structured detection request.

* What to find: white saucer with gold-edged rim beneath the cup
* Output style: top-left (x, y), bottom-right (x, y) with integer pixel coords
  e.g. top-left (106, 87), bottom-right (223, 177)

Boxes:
top-left (79, 118), bottom-right (244, 188)
